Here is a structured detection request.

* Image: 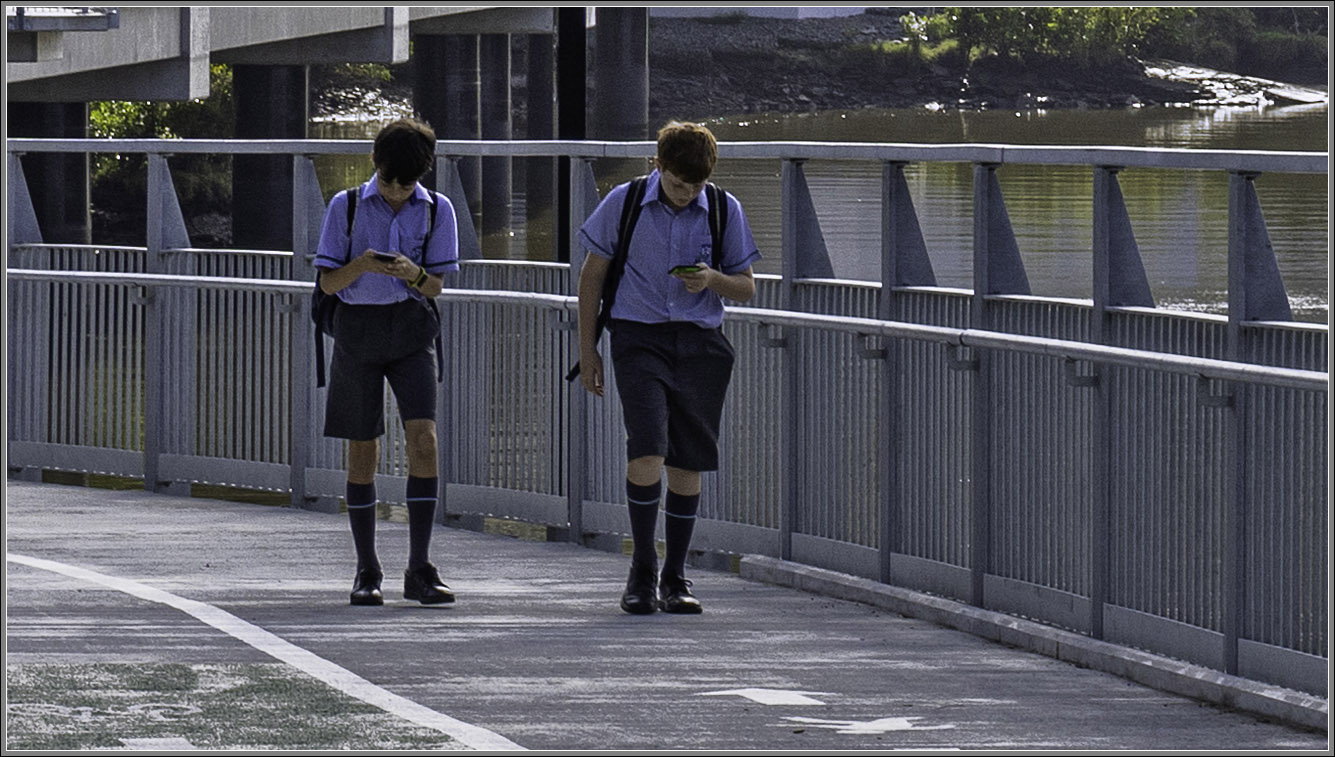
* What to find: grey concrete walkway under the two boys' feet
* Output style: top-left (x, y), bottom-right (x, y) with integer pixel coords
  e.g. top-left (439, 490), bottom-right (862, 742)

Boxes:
top-left (5, 481), bottom-right (1328, 752)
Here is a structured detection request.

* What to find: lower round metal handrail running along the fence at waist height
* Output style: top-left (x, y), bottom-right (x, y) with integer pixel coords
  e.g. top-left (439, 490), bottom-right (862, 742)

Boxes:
top-left (8, 268), bottom-right (1330, 391)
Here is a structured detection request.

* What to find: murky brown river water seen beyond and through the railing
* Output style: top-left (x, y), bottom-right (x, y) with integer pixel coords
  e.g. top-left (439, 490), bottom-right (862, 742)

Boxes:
top-left (309, 104), bottom-right (1330, 323)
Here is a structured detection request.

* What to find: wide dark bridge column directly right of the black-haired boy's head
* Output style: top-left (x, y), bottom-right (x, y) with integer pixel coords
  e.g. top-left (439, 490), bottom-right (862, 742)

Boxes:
top-left (413, 35), bottom-right (482, 228)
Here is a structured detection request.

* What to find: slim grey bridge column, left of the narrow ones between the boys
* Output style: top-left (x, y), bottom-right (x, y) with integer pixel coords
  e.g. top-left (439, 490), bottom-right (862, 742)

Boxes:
top-left (481, 35), bottom-right (514, 258)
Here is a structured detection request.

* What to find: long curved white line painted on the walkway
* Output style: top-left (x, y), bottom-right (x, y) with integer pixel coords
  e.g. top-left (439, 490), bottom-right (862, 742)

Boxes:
top-left (5, 553), bottom-right (523, 750)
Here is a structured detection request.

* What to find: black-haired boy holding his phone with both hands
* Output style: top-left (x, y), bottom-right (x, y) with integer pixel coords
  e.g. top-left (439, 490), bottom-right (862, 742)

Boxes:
top-left (315, 119), bottom-right (459, 605)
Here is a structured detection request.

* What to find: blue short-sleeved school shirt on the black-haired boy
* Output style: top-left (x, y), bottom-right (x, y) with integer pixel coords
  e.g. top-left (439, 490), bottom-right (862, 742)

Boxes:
top-left (315, 176), bottom-right (459, 304)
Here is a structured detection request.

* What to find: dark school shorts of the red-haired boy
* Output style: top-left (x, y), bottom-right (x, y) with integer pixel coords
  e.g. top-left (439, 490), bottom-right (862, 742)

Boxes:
top-left (610, 320), bottom-right (736, 471)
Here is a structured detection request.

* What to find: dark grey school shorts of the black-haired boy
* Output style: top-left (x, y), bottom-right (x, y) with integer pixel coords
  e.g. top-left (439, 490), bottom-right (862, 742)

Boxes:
top-left (324, 299), bottom-right (439, 442)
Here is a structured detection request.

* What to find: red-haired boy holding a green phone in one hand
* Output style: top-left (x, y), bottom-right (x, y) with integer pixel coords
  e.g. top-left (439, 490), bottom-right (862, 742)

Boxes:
top-left (579, 121), bottom-right (760, 614)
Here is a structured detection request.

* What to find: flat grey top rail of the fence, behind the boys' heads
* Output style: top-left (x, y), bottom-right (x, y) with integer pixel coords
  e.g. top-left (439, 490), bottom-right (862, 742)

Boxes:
top-left (5, 138), bottom-right (1330, 174)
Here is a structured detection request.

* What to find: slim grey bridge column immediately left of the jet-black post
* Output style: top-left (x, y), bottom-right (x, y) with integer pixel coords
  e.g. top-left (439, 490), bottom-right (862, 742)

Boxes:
top-left (525, 35), bottom-right (557, 260)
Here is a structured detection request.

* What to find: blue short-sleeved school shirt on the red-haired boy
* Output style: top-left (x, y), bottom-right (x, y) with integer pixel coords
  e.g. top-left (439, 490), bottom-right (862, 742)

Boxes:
top-left (579, 171), bottom-right (760, 328)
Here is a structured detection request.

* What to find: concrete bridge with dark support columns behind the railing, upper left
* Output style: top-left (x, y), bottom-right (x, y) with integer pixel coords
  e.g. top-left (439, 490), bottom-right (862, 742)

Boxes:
top-left (7, 7), bottom-right (649, 259)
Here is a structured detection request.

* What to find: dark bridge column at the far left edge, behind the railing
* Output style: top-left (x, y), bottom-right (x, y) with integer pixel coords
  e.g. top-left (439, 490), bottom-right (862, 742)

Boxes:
top-left (7, 103), bottom-right (92, 244)
